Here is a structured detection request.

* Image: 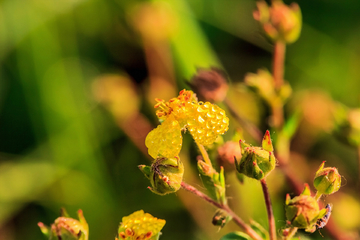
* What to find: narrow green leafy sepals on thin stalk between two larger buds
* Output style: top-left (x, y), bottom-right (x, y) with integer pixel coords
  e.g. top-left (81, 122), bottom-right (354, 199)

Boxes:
top-left (197, 161), bottom-right (226, 204)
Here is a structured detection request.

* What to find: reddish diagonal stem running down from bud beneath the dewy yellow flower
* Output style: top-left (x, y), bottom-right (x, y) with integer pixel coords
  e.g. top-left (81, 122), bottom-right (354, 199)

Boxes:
top-left (181, 182), bottom-right (263, 240)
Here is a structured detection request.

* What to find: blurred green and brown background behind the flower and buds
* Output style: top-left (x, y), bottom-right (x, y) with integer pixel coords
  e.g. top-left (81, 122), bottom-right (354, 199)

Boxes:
top-left (0, 0), bottom-right (360, 240)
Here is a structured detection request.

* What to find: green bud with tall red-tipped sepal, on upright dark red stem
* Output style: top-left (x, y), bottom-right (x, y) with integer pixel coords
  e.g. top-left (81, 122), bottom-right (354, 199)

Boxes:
top-left (235, 131), bottom-right (276, 180)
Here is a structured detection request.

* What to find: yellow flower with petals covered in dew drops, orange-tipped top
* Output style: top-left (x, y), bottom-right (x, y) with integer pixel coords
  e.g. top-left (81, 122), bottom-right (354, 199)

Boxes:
top-left (145, 90), bottom-right (229, 158)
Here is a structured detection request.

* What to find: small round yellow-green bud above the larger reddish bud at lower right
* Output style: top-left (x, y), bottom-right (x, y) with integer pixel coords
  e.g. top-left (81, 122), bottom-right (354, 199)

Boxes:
top-left (314, 161), bottom-right (341, 195)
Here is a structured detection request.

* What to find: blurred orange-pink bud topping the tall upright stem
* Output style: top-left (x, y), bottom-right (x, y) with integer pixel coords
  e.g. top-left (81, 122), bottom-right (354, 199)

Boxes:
top-left (253, 1), bottom-right (302, 43)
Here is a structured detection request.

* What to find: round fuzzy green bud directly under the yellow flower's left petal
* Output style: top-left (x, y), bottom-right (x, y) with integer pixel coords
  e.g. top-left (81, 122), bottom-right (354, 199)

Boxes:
top-left (139, 157), bottom-right (184, 195)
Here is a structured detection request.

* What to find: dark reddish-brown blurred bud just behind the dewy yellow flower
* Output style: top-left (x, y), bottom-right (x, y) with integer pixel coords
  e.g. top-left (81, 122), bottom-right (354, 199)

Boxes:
top-left (190, 67), bottom-right (229, 103)
